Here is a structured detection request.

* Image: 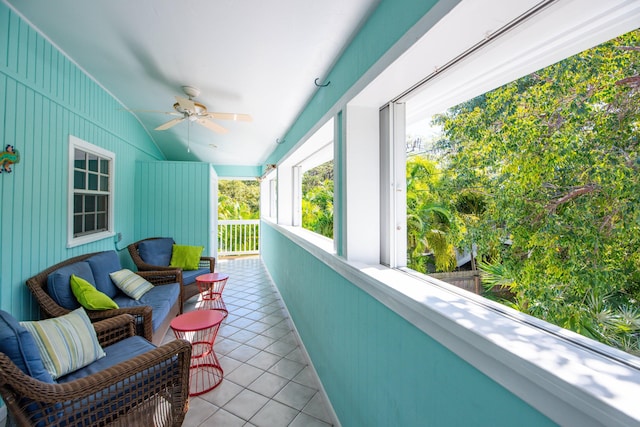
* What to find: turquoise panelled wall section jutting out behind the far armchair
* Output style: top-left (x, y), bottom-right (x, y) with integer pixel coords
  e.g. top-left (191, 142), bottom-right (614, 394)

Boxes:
top-left (134, 161), bottom-right (216, 255)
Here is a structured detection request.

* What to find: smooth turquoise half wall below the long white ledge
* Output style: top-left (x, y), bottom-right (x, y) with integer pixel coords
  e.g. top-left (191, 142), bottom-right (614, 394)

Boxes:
top-left (260, 226), bottom-right (554, 427)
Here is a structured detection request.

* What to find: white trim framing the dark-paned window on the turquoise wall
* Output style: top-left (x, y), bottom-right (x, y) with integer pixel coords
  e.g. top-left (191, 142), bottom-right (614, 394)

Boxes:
top-left (67, 135), bottom-right (116, 248)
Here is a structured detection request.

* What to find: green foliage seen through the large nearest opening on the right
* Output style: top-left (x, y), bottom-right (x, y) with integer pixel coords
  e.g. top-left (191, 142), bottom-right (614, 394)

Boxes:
top-left (416, 30), bottom-right (640, 353)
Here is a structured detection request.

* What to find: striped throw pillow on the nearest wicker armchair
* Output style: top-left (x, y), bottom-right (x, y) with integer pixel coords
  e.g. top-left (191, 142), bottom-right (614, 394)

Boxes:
top-left (20, 307), bottom-right (105, 380)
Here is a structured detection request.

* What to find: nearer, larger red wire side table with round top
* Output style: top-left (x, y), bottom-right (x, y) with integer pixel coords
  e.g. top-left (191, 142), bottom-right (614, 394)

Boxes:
top-left (171, 310), bottom-right (226, 396)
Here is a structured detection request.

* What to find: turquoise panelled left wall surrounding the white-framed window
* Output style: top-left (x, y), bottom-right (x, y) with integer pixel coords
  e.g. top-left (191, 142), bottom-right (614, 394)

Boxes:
top-left (0, 3), bottom-right (164, 319)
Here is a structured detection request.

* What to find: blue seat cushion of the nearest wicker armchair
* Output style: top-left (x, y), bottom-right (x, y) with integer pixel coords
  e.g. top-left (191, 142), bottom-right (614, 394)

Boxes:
top-left (58, 336), bottom-right (156, 383)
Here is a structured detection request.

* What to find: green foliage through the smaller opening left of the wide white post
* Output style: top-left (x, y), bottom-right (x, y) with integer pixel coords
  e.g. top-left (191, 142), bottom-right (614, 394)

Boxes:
top-left (302, 161), bottom-right (333, 239)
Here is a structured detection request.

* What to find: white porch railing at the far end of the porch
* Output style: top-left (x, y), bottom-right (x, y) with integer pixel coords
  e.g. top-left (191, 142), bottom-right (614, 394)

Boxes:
top-left (218, 219), bottom-right (260, 255)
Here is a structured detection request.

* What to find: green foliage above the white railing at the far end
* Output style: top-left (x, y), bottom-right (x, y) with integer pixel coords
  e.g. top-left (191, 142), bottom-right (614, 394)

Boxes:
top-left (218, 180), bottom-right (260, 219)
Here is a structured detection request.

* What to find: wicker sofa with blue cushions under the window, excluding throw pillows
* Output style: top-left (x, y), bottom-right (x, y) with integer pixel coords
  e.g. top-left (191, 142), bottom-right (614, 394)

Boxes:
top-left (27, 251), bottom-right (184, 345)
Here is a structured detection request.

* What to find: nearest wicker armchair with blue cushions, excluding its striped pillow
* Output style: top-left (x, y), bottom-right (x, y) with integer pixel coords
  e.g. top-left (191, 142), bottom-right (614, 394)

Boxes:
top-left (0, 312), bottom-right (191, 427)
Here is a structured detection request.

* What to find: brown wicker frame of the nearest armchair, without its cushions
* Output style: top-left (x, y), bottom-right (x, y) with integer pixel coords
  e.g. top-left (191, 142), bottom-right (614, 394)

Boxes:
top-left (0, 315), bottom-right (191, 427)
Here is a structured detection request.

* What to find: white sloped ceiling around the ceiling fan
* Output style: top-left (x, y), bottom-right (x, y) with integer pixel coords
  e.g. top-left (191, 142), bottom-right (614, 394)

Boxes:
top-left (5, 0), bottom-right (379, 170)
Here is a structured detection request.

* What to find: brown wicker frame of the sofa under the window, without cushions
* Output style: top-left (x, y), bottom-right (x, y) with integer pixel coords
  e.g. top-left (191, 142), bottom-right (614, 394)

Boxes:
top-left (27, 253), bottom-right (184, 344)
